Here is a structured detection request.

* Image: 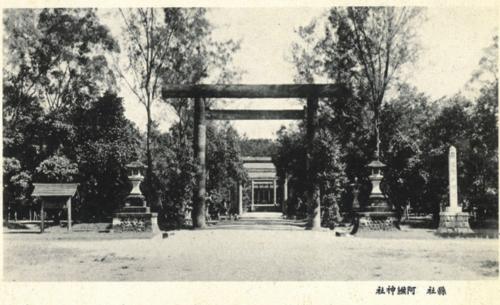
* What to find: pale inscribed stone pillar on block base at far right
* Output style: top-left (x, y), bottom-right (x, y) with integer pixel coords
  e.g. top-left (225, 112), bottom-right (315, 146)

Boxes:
top-left (438, 146), bottom-right (473, 234)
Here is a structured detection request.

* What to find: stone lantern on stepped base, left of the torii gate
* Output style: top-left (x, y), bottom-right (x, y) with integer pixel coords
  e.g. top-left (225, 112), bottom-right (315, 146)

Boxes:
top-left (113, 161), bottom-right (153, 232)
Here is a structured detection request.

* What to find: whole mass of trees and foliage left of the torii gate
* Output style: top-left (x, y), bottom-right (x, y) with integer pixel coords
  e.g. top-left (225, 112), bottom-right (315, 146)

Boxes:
top-left (3, 8), bottom-right (244, 220)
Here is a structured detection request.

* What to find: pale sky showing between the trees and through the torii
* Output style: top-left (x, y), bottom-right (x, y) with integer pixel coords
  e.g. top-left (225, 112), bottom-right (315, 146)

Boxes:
top-left (115, 7), bottom-right (498, 138)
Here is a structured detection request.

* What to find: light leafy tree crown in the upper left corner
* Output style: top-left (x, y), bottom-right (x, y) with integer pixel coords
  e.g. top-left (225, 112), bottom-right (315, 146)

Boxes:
top-left (4, 9), bottom-right (118, 111)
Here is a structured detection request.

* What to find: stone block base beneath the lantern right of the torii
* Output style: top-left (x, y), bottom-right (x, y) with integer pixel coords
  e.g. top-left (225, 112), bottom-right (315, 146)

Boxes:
top-left (351, 212), bottom-right (400, 234)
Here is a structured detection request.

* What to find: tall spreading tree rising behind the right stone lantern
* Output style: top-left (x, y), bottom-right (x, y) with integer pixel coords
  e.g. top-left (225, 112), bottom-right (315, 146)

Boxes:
top-left (293, 7), bottom-right (422, 159)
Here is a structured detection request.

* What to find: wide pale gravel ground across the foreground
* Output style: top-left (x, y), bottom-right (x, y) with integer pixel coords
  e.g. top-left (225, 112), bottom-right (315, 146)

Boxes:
top-left (4, 229), bottom-right (498, 281)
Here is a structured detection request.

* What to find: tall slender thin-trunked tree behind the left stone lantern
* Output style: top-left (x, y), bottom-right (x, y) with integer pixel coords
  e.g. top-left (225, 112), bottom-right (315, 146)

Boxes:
top-left (119, 8), bottom-right (178, 200)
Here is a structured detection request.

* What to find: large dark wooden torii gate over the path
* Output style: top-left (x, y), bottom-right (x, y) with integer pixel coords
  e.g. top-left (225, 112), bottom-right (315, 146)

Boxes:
top-left (162, 84), bottom-right (344, 229)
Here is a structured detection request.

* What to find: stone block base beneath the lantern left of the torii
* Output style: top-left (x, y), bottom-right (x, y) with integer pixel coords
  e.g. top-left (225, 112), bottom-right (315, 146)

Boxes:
top-left (112, 210), bottom-right (153, 233)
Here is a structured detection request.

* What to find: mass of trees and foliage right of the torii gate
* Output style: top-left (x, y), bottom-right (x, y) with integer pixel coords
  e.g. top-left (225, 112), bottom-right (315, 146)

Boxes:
top-left (284, 8), bottom-right (498, 220)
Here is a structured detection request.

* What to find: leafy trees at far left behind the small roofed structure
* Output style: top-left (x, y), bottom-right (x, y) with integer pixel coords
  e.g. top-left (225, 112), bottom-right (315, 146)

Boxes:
top-left (3, 9), bottom-right (137, 218)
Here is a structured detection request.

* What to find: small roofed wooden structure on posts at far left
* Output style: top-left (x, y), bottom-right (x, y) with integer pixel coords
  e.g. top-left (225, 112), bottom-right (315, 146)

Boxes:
top-left (31, 183), bottom-right (78, 233)
